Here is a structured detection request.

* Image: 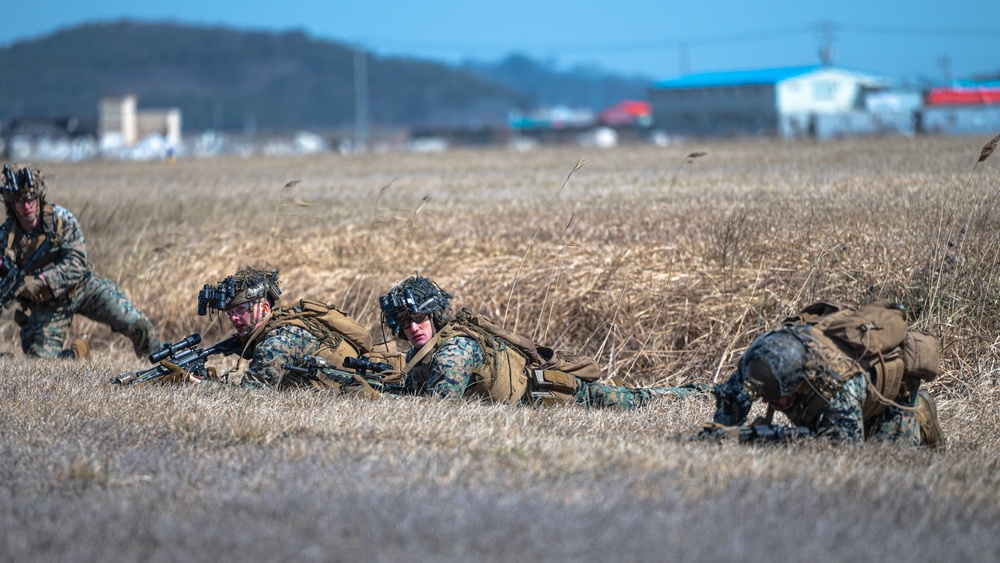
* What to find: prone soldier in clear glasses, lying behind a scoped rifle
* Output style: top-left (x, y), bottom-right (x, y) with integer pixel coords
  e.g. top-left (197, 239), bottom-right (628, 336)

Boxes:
top-left (189, 266), bottom-right (384, 389)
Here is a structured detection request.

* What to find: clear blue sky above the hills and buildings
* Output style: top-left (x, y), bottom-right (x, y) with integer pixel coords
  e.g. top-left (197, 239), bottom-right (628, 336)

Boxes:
top-left (7, 0), bottom-right (1000, 81)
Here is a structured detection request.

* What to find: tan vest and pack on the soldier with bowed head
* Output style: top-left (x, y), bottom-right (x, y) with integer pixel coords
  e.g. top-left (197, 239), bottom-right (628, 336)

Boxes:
top-left (779, 300), bottom-right (940, 425)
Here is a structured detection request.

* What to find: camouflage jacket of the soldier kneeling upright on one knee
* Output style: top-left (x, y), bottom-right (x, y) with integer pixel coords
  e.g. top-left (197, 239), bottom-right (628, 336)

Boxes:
top-left (0, 205), bottom-right (93, 305)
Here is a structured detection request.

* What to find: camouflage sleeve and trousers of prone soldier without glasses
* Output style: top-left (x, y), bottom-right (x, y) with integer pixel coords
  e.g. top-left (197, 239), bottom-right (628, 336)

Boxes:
top-left (403, 328), bottom-right (697, 410)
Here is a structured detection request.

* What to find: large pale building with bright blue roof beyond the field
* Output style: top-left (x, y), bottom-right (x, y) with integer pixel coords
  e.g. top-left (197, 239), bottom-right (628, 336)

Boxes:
top-left (649, 65), bottom-right (888, 138)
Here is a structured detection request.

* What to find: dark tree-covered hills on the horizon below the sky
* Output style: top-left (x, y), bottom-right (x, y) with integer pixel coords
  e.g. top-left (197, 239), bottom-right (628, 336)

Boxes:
top-left (0, 20), bottom-right (646, 131)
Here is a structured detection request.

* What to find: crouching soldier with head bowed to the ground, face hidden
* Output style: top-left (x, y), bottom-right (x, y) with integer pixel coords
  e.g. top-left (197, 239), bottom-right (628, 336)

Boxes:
top-left (714, 301), bottom-right (945, 447)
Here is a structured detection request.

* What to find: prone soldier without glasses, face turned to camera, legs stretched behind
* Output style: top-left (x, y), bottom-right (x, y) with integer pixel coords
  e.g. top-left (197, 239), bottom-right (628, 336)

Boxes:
top-left (379, 277), bottom-right (712, 410)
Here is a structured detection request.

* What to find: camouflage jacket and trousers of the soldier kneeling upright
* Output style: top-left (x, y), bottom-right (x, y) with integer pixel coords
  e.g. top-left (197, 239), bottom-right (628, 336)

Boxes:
top-left (0, 205), bottom-right (160, 357)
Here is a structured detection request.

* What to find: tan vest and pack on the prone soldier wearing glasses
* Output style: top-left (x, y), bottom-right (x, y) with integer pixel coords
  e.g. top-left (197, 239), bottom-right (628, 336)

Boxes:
top-left (261, 299), bottom-right (382, 389)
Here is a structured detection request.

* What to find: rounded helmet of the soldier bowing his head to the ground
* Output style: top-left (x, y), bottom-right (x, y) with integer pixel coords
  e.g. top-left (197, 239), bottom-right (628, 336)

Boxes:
top-left (739, 329), bottom-right (808, 401)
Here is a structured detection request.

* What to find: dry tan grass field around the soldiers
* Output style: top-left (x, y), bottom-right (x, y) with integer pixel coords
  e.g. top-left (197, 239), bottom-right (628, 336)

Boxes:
top-left (0, 138), bottom-right (1000, 561)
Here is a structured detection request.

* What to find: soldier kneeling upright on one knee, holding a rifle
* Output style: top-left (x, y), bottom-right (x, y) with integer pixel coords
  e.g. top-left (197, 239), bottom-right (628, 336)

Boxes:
top-left (0, 165), bottom-right (160, 359)
